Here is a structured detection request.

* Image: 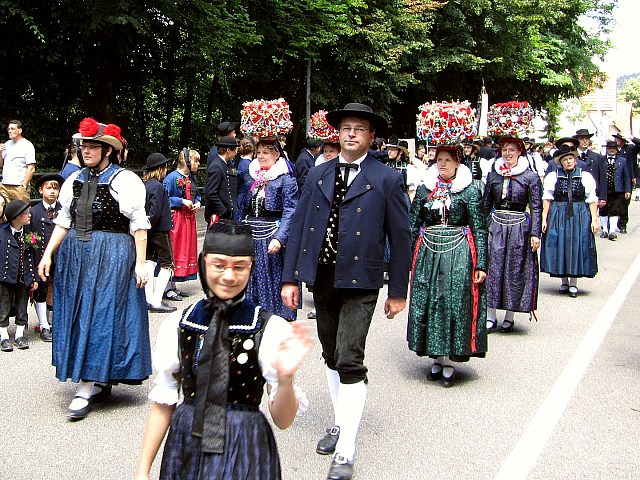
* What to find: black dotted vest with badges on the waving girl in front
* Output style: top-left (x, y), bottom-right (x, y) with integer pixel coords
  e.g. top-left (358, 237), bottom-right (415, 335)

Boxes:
top-left (178, 300), bottom-right (271, 409)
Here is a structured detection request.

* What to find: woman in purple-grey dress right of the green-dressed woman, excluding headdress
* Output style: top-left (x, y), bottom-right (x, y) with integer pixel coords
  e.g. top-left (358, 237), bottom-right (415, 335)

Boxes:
top-left (482, 137), bottom-right (542, 333)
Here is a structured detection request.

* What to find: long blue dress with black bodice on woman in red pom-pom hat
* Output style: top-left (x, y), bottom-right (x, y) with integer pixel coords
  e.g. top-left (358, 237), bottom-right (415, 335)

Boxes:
top-left (52, 164), bottom-right (151, 383)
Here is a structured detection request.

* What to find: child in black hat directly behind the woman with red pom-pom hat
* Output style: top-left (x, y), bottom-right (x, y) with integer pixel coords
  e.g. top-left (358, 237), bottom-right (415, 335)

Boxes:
top-left (30, 173), bottom-right (64, 342)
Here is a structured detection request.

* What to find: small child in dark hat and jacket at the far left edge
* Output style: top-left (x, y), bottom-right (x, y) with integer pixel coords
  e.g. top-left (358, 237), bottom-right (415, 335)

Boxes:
top-left (0, 200), bottom-right (38, 352)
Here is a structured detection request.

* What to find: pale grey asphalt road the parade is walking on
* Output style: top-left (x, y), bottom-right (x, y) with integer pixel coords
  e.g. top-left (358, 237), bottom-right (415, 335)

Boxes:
top-left (0, 207), bottom-right (640, 480)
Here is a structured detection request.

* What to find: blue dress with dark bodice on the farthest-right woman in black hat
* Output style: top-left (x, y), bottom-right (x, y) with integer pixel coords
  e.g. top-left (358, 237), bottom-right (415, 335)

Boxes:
top-left (540, 168), bottom-right (598, 278)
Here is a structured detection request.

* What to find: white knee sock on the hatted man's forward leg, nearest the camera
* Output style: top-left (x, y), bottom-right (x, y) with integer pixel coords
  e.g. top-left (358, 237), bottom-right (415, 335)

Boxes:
top-left (336, 381), bottom-right (367, 460)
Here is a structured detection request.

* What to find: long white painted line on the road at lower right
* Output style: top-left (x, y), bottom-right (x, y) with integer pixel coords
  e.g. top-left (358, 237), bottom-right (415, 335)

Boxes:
top-left (495, 251), bottom-right (640, 480)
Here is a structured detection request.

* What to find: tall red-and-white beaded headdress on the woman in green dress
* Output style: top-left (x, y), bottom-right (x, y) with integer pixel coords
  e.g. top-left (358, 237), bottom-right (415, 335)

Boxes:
top-left (416, 100), bottom-right (478, 145)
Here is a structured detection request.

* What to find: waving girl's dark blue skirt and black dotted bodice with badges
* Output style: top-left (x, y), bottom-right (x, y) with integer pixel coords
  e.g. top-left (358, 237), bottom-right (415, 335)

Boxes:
top-left (160, 300), bottom-right (282, 480)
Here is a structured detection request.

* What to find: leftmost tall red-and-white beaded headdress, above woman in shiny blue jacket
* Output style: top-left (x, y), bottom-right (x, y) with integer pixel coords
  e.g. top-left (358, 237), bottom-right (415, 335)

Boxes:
top-left (240, 98), bottom-right (293, 138)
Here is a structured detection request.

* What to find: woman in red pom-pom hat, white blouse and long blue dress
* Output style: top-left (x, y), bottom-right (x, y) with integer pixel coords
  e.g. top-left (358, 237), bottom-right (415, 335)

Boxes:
top-left (38, 118), bottom-right (151, 420)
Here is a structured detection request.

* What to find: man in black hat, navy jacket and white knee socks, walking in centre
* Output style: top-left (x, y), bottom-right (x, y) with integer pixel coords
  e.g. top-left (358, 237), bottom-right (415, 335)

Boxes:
top-left (282, 103), bottom-right (411, 480)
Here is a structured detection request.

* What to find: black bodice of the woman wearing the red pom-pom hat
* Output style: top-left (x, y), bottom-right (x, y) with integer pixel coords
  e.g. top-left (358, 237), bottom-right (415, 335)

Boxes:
top-left (70, 164), bottom-right (129, 233)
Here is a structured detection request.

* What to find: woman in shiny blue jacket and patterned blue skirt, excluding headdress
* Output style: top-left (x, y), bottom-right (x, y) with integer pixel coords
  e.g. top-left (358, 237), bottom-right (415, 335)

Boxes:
top-left (238, 137), bottom-right (298, 321)
